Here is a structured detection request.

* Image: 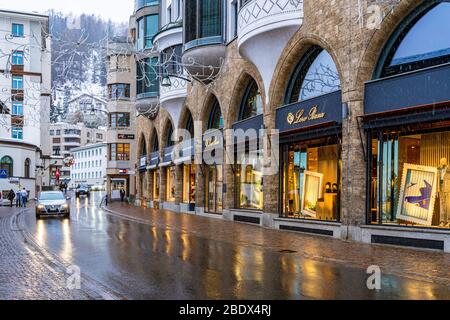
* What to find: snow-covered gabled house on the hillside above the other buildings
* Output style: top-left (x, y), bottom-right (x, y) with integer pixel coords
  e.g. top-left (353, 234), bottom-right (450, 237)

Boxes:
top-left (68, 93), bottom-right (108, 128)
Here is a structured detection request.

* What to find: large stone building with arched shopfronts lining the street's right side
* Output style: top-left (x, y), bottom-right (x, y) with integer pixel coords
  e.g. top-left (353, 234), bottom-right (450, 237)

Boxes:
top-left (131, 0), bottom-right (450, 252)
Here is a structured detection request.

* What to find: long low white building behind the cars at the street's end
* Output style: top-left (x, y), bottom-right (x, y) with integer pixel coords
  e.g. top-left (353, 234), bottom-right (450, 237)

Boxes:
top-left (69, 143), bottom-right (107, 188)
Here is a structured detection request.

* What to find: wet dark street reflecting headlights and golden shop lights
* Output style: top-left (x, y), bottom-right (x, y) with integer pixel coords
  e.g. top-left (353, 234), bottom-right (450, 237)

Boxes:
top-left (20, 193), bottom-right (450, 299)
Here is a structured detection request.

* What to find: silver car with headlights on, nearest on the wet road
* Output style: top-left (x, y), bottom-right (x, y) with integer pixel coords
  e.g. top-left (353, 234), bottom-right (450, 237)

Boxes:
top-left (36, 191), bottom-right (70, 219)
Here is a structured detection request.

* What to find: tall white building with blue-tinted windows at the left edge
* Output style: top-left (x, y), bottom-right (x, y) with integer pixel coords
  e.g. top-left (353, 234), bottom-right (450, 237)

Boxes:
top-left (0, 10), bottom-right (51, 197)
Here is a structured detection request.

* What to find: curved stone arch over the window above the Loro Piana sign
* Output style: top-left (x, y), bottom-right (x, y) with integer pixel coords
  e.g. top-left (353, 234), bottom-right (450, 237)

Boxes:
top-left (269, 31), bottom-right (347, 121)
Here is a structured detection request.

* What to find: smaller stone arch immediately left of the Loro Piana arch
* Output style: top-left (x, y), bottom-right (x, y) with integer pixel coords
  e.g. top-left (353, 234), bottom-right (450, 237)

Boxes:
top-left (226, 70), bottom-right (267, 127)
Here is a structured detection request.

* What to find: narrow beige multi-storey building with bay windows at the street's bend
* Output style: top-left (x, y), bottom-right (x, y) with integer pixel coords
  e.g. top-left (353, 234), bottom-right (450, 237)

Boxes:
top-left (106, 39), bottom-right (137, 200)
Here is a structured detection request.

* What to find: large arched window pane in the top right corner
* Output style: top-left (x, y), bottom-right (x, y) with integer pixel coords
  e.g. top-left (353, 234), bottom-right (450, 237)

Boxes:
top-left (374, 1), bottom-right (450, 79)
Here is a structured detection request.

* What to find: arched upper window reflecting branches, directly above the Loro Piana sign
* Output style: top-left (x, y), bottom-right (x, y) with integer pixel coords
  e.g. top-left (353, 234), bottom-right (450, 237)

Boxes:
top-left (285, 46), bottom-right (341, 104)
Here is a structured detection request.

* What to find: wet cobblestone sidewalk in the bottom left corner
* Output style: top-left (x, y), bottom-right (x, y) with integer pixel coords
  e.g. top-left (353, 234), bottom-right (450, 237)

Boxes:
top-left (0, 207), bottom-right (115, 300)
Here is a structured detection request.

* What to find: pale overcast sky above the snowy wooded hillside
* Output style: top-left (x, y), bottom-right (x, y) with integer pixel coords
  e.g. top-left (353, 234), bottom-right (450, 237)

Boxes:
top-left (0, 0), bottom-right (134, 22)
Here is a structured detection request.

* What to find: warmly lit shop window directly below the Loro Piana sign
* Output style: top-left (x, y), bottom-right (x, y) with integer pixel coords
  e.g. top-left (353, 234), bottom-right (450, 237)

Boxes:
top-left (281, 137), bottom-right (341, 221)
